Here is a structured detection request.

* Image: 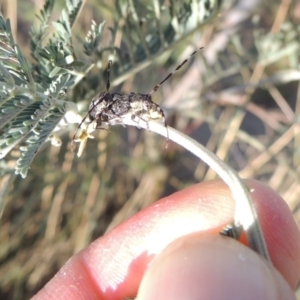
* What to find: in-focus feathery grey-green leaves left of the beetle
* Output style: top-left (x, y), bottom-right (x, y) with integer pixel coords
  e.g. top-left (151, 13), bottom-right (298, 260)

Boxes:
top-left (0, 0), bottom-right (106, 177)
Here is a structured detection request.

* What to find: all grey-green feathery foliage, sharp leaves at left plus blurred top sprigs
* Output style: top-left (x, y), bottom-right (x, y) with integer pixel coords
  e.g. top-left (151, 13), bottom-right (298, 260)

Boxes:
top-left (0, 0), bottom-right (219, 177)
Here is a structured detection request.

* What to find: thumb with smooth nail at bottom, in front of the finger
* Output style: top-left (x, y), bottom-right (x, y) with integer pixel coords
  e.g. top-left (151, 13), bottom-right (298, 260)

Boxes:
top-left (137, 234), bottom-right (295, 300)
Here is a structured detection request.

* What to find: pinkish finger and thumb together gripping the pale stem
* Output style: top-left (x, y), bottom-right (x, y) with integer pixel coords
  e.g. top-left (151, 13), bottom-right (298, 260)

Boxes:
top-left (33, 180), bottom-right (300, 300)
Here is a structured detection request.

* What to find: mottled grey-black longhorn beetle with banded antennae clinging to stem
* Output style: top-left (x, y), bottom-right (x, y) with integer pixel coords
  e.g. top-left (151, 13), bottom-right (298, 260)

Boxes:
top-left (72, 47), bottom-right (203, 156)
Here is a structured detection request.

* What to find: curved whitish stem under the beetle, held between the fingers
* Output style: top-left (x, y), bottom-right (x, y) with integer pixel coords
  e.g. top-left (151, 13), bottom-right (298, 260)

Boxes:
top-left (122, 115), bottom-right (271, 261)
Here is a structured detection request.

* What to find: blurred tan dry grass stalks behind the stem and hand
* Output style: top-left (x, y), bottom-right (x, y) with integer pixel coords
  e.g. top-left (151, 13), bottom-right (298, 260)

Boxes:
top-left (0, 0), bottom-right (300, 300)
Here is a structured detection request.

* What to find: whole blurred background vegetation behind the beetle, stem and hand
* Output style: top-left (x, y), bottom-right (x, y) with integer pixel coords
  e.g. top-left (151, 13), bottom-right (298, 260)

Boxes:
top-left (0, 0), bottom-right (300, 300)
